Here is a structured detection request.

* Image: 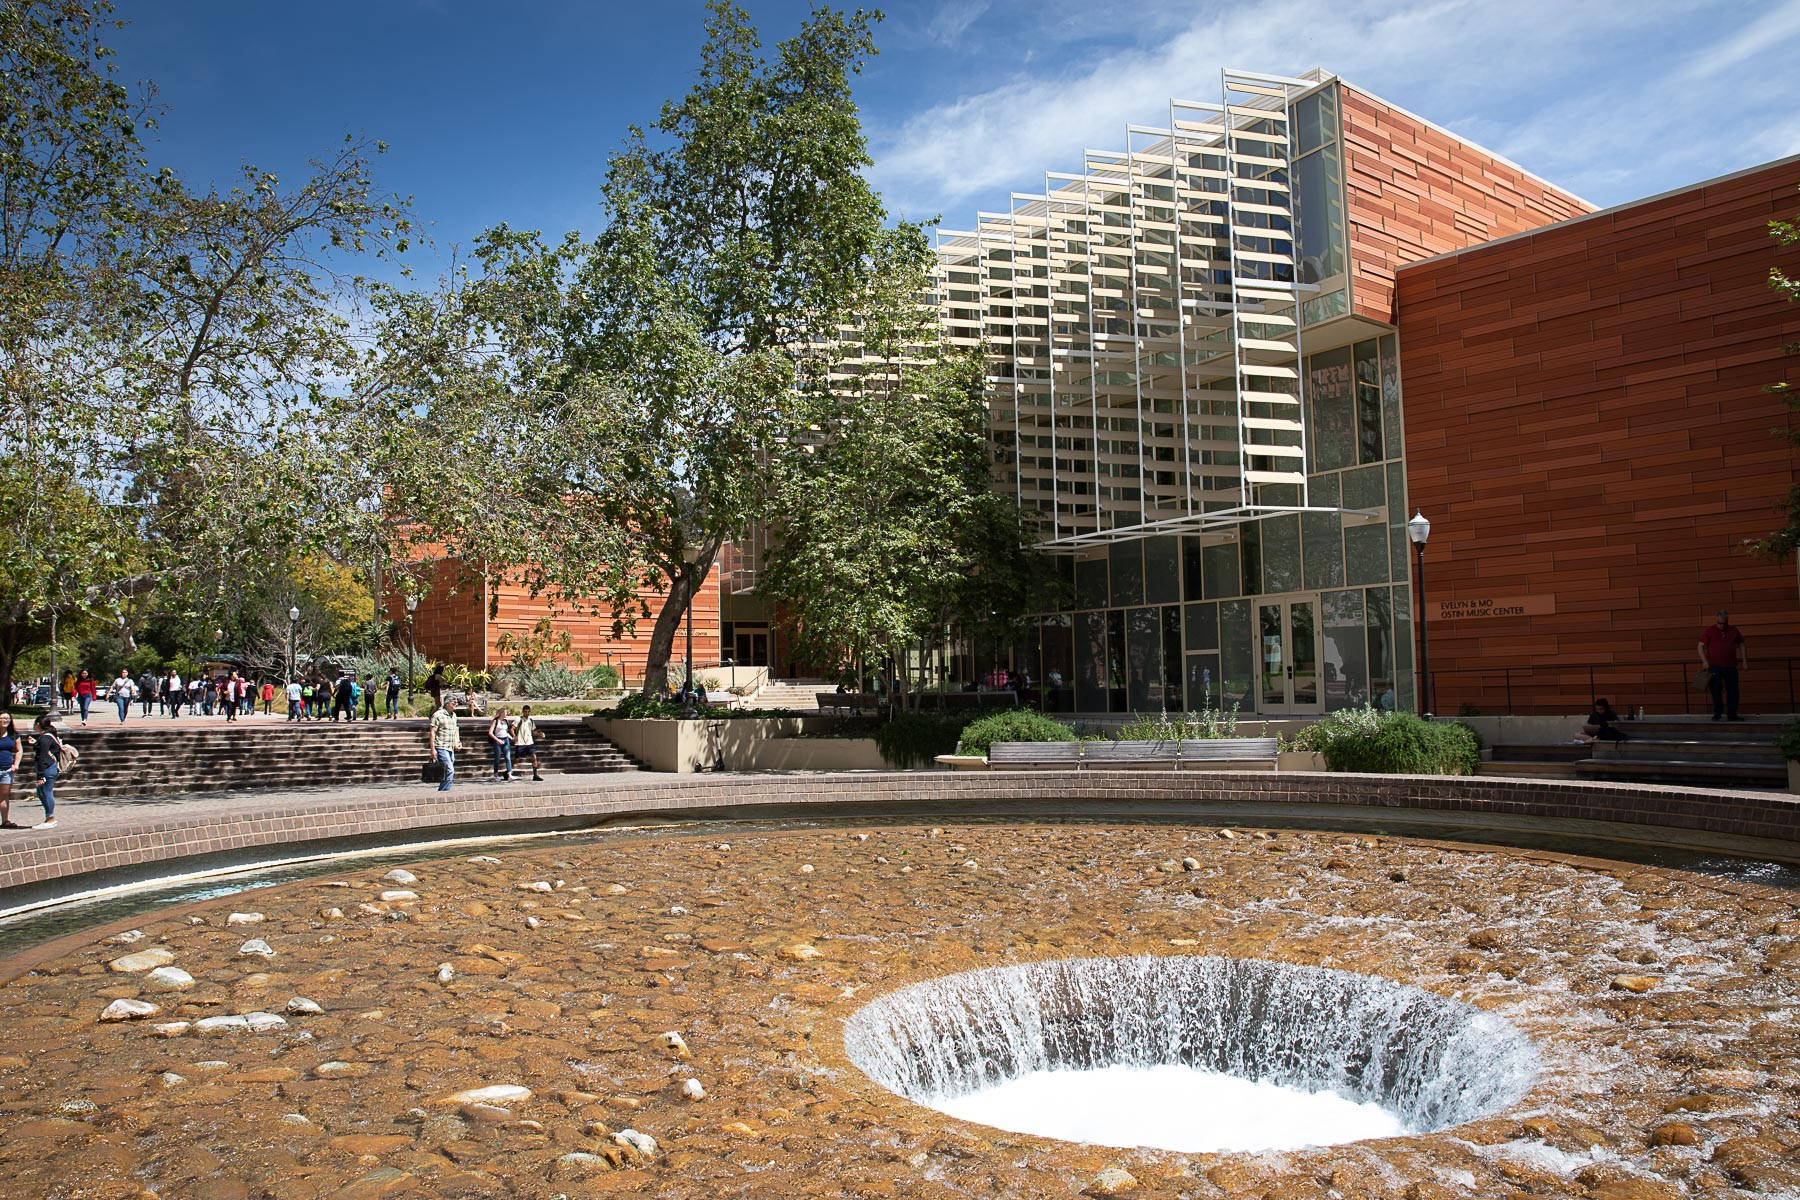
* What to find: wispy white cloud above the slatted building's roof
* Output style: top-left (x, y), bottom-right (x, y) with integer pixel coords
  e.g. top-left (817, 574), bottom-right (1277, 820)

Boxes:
top-left (875, 0), bottom-right (1800, 218)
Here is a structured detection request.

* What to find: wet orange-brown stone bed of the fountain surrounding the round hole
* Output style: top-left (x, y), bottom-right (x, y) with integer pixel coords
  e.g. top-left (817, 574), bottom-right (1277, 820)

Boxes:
top-left (0, 826), bottom-right (1800, 1200)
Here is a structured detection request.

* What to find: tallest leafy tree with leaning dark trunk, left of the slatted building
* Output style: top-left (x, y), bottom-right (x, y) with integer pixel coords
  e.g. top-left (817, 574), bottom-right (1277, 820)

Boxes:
top-left (371, 0), bottom-right (884, 693)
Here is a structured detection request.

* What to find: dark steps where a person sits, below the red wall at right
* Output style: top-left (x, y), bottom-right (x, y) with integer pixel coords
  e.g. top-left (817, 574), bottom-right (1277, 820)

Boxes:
top-left (1481, 718), bottom-right (1787, 788)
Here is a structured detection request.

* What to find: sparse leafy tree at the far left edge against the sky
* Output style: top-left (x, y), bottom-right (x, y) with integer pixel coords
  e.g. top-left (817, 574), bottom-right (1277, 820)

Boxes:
top-left (0, 0), bottom-right (409, 685)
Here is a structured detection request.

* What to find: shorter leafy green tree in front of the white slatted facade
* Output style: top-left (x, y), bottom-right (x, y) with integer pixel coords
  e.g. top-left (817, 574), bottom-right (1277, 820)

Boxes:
top-left (758, 228), bottom-right (1051, 705)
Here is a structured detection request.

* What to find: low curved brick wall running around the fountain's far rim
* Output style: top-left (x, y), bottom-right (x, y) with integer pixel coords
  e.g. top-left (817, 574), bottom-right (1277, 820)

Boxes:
top-left (0, 770), bottom-right (1800, 909)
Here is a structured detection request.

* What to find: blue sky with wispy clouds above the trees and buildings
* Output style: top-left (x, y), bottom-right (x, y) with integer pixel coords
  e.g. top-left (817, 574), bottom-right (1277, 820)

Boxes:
top-left (113, 0), bottom-right (1800, 273)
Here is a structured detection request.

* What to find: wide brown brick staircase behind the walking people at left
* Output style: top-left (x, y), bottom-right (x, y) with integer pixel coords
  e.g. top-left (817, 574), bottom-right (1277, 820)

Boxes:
top-left (14, 718), bottom-right (639, 801)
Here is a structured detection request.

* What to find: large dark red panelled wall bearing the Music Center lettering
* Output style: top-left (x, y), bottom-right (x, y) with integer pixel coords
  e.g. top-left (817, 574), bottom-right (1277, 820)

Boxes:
top-left (1399, 160), bottom-right (1800, 712)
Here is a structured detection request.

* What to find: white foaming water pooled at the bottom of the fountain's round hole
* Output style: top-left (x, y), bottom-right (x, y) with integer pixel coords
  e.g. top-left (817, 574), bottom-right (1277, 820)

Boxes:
top-left (932, 1063), bottom-right (1408, 1153)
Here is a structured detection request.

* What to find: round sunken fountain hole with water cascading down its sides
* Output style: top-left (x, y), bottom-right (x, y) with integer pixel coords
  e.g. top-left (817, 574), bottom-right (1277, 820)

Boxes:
top-left (844, 957), bottom-right (1537, 1151)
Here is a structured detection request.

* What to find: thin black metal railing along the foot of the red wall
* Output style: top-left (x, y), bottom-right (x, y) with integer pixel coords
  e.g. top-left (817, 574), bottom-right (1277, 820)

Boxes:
top-left (1431, 657), bottom-right (1800, 716)
